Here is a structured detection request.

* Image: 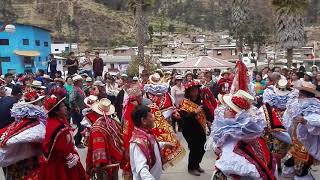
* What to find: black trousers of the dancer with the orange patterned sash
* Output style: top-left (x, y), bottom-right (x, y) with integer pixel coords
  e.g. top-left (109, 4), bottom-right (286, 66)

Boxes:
top-left (182, 129), bottom-right (206, 170)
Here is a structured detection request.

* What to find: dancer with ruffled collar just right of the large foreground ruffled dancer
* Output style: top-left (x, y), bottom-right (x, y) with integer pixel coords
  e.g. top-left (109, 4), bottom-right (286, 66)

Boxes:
top-left (260, 79), bottom-right (298, 172)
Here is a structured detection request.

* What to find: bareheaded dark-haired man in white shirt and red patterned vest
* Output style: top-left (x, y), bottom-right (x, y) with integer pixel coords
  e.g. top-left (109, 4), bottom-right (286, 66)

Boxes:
top-left (130, 105), bottom-right (169, 180)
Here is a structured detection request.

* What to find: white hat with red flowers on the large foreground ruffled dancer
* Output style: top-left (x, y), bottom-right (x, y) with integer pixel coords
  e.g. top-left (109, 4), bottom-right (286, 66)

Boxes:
top-left (222, 90), bottom-right (254, 113)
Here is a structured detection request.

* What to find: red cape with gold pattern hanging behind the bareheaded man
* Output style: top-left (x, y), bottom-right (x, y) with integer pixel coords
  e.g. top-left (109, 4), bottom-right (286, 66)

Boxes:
top-left (149, 104), bottom-right (186, 168)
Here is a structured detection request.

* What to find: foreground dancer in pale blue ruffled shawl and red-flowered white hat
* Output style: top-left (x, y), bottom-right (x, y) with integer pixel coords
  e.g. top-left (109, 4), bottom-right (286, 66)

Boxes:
top-left (210, 90), bottom-right (276, 180)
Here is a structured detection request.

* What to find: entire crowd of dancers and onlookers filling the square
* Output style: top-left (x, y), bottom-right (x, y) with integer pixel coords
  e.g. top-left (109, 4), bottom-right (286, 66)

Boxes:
top-left (0, 52), bottom-right (320, 180)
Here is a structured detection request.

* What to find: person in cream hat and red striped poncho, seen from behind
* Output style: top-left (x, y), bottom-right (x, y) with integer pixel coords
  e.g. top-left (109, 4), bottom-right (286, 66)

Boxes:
top-left (86, 98), bottom-right (124, 180)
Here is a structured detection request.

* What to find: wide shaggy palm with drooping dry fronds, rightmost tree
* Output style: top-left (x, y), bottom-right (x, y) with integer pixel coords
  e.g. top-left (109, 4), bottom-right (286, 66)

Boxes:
top-left (272, 0), bottom-right (309, 67)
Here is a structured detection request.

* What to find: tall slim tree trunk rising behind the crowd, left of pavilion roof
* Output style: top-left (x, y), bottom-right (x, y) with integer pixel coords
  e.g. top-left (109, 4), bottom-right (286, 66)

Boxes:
top-left (128, 0), bottom-right (154, 73)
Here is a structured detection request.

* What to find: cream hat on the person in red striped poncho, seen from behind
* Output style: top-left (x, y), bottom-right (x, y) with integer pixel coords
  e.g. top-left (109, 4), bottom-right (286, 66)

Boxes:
top-left (91, 98), bottom-right (115, 116)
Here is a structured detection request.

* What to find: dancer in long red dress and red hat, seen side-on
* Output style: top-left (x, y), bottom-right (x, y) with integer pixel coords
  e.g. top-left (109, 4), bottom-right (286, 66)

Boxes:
top-left (39, 95), bottom-right (86, 180)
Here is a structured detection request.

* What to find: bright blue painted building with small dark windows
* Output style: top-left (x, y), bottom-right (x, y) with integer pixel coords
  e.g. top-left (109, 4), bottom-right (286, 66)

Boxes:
top-left (0, 22), bottom-right (51, 74)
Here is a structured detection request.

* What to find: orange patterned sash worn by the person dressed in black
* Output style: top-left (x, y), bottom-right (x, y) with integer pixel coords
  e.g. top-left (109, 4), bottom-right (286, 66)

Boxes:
top-left (180, 99), bottom-right (207, 132)
